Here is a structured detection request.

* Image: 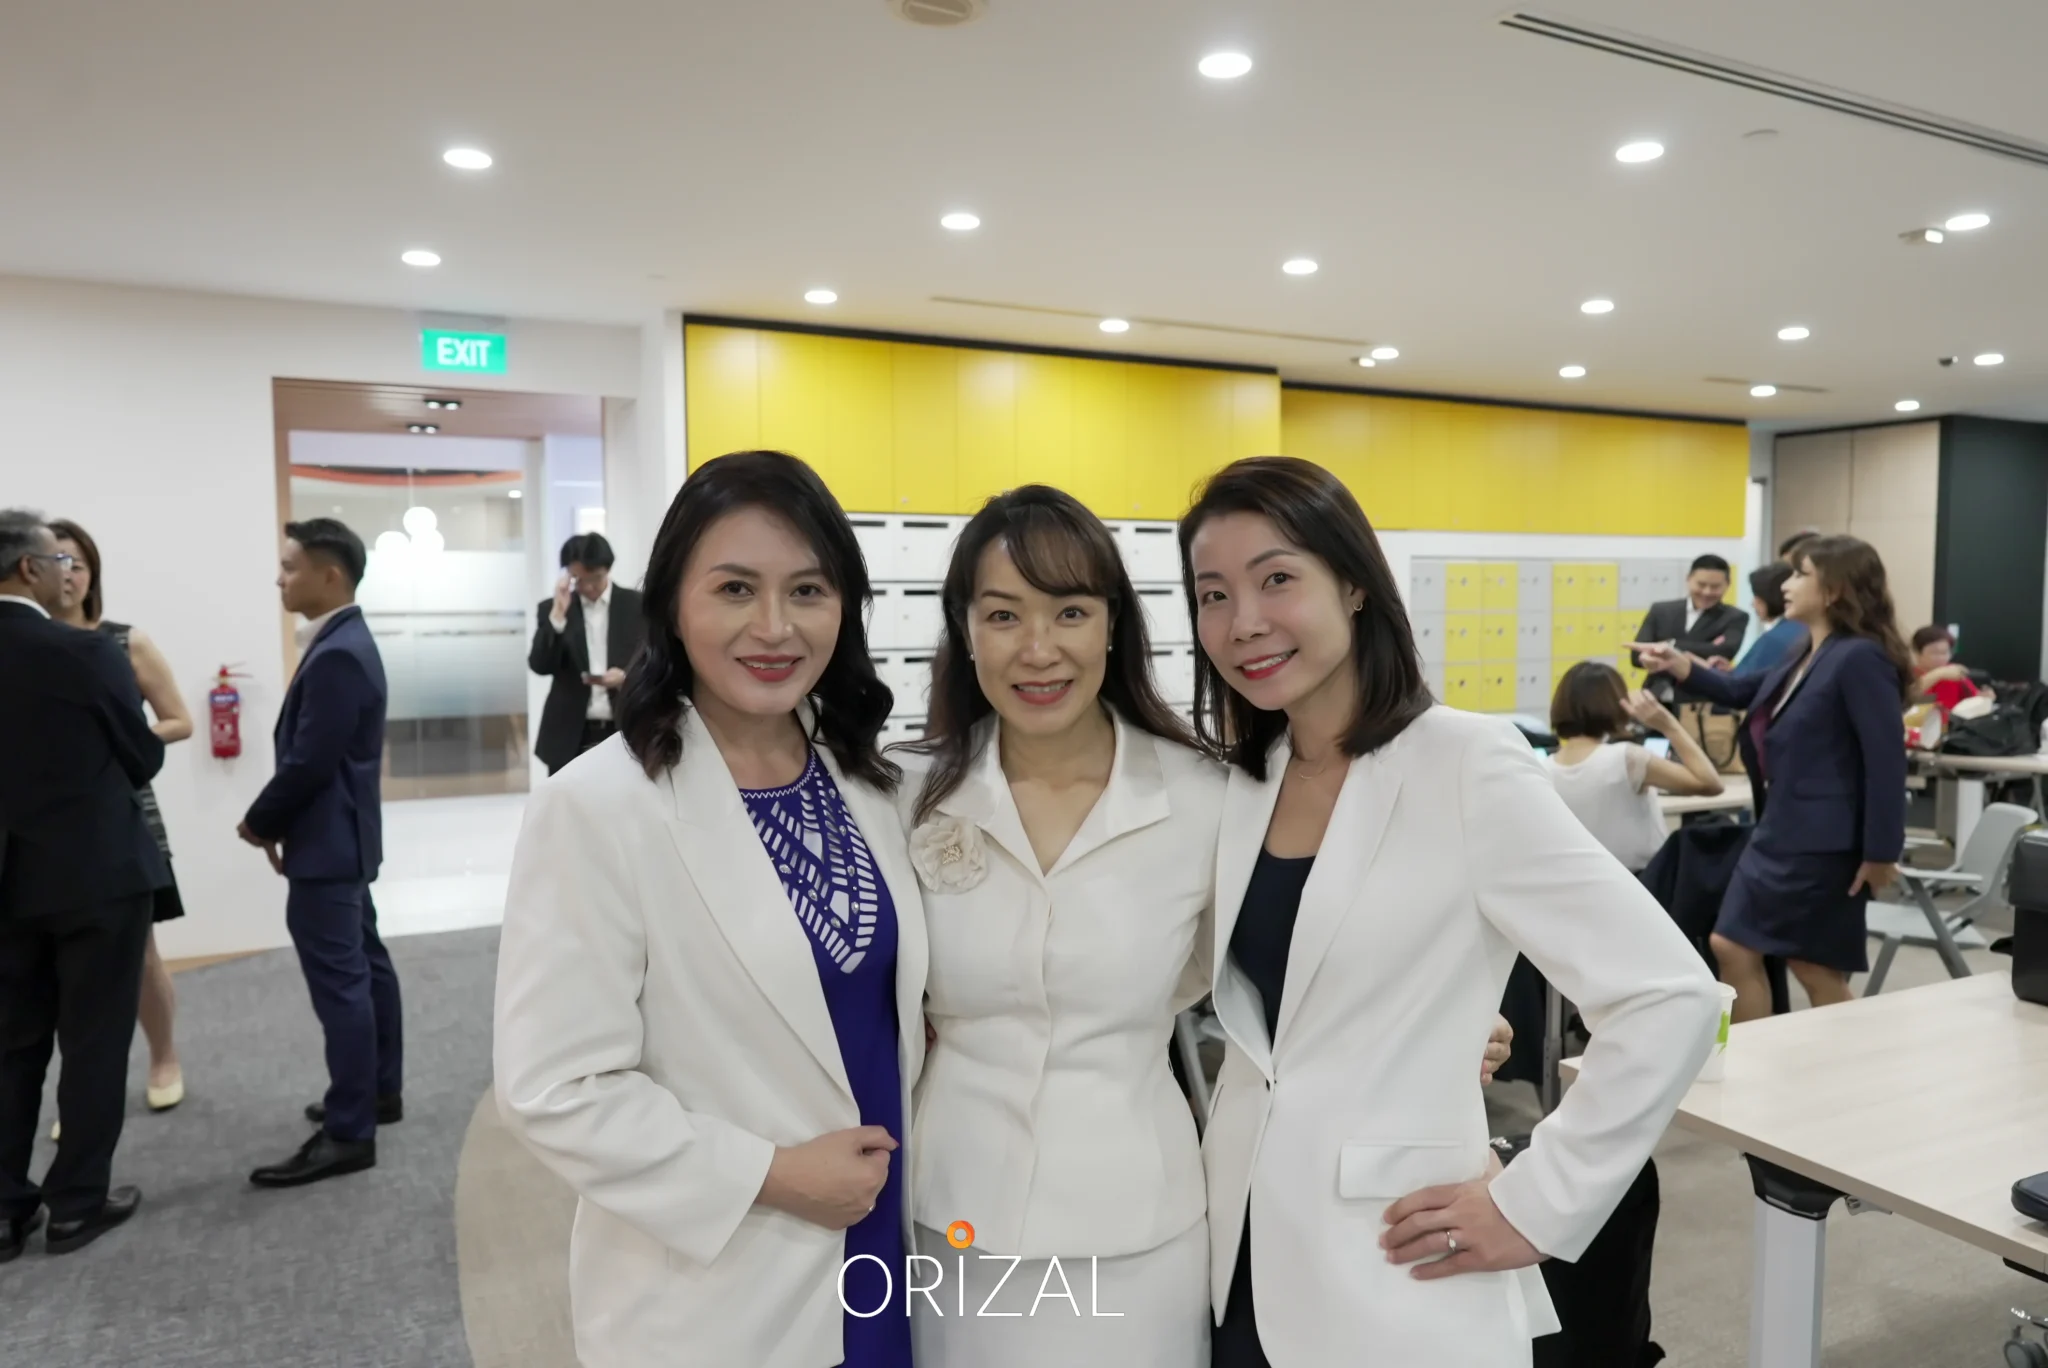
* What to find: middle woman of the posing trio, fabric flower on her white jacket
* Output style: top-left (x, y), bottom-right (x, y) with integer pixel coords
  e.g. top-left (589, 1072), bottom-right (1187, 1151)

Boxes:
top-left (897, 485), bottom-right (1223, 1368)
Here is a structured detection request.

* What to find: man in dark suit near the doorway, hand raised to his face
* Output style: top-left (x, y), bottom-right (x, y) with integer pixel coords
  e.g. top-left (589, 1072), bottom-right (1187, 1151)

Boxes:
top-left (526, 532), bottom-right (647, 774)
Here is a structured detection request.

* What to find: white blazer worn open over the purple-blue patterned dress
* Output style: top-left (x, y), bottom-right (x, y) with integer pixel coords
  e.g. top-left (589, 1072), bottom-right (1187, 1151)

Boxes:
top-left (494, 711), bottom-right (926, 1368)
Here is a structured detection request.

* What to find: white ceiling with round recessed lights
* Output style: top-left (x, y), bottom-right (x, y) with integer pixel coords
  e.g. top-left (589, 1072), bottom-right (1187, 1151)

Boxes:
top-left (0, 0), bottom-right (2048, 426)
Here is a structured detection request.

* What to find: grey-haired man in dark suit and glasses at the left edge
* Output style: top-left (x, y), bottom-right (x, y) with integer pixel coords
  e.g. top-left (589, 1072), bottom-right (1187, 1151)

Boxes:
top-left (0, 510), bottom-right (170, 1264)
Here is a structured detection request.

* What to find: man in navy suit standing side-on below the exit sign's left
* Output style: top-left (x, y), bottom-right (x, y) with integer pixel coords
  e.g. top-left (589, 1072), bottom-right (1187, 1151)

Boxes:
top-left (238, 518), bottom-right (403, 1188)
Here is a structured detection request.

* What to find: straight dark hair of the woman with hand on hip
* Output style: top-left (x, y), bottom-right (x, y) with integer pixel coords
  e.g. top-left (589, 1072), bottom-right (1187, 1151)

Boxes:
top-left (1180, 457), bottom-right (1434, 780)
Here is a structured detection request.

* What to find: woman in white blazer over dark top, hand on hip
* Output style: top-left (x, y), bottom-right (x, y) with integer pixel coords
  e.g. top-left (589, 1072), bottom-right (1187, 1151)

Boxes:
top-left (1180, 457), bottom-right (1718, 1368)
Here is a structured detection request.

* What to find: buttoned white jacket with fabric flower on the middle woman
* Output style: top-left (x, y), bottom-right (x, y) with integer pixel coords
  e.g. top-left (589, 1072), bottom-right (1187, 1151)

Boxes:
top-left (897, 719), bottom-right (1225, 1257)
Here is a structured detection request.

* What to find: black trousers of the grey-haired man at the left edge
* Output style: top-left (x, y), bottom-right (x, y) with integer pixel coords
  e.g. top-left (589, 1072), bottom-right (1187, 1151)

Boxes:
top-left (0, 893), bottom-right (152, 1221)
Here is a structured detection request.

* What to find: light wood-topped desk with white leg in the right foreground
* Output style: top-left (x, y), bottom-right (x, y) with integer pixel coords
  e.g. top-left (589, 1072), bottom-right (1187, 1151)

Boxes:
top-left (1565, 973), bottom-right (2048, 1368)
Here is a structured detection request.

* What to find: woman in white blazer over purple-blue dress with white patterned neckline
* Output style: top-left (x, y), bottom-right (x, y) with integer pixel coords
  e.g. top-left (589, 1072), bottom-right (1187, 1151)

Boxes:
top-left (494, 453), bottom-right (926, 1368)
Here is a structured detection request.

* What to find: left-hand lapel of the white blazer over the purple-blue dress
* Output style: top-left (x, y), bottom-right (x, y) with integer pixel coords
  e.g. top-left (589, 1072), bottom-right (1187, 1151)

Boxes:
top-left (668, 709), bottom-right (847, 1098)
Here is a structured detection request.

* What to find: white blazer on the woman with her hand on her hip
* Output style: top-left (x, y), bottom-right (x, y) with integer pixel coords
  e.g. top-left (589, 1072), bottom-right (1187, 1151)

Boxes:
top-left (1204, 707), bottom-right (1720, 1368)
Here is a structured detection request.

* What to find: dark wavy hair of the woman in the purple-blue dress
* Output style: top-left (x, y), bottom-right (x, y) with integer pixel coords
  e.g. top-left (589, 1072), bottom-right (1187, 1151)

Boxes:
top-left (618, 451), bottom-right (903, 790)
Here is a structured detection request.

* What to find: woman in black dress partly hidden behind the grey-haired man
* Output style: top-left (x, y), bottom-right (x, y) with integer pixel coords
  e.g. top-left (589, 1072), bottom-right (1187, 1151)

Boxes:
top-left (49, 518), bottom-right (193, 1112)
